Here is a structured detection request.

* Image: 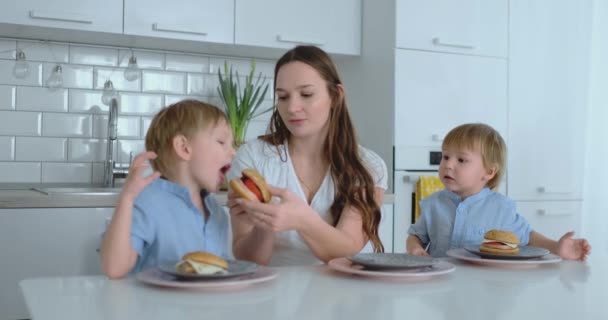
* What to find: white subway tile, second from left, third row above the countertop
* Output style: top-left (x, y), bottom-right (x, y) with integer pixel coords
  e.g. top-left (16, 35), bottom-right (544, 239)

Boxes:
top-left (42, 113), bottom-right (93, 137)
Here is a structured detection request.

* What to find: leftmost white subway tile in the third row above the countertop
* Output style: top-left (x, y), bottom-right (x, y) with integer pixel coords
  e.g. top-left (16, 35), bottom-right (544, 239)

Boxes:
top-left (0, 111), bottom-right (42, 136)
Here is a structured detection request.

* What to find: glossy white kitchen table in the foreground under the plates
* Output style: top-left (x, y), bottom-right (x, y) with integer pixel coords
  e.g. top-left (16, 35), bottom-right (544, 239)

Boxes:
top-left (20, 256), bottom-right (608, 320)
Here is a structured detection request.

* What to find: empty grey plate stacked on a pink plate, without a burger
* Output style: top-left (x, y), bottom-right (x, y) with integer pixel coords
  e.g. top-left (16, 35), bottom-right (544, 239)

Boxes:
top-left (348, 253), bottom-right (434, 270)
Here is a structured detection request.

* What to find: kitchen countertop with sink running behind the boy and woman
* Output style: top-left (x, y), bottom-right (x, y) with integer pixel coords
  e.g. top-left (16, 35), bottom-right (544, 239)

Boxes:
top-left (0, 183), bottom-right (394, 209)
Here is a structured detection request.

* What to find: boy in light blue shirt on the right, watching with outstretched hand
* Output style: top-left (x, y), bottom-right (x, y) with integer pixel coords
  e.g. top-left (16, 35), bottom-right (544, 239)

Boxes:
top-left (406, 123), bottom-right (591, 260)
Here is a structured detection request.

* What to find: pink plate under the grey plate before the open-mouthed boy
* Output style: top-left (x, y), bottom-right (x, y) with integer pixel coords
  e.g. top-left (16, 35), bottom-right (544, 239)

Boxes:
top-left (135, 266), bottom-right (277, 289)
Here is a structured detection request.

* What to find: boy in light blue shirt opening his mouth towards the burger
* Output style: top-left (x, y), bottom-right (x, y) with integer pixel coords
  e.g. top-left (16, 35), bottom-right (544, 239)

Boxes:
top-left (101, 100), bottom-right (235, 279)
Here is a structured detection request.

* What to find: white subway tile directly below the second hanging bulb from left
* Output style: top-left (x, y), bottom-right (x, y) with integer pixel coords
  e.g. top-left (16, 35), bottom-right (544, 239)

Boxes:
top-left (17, 87), bottom-right (68, 112)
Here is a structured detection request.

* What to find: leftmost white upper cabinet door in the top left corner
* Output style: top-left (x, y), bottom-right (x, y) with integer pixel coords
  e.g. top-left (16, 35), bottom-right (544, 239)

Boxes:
top-left (0, 0), bottom-right (122, 33)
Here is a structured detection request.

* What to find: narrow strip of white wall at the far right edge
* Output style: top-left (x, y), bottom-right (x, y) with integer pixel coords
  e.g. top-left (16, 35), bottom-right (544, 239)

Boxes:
top-left (583, 1), bottom-right (608, 255)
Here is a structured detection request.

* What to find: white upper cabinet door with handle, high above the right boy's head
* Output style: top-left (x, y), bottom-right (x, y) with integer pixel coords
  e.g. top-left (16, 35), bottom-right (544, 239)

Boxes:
top-left (397, 0), bottom-right (509, 57)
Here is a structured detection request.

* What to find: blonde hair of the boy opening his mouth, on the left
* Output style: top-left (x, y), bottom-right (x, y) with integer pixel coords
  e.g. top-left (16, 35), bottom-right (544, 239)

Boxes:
top-left (146, 100), bottom-right (229, 174)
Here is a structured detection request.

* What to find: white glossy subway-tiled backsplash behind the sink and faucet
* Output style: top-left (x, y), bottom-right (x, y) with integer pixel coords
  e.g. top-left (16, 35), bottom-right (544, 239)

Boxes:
top-left (0, 39), bottom-right (274, 183)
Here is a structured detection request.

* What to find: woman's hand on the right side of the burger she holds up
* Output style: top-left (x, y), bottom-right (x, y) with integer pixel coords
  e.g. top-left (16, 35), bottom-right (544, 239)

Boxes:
top-left (236, 186), bottom-right (313, 232)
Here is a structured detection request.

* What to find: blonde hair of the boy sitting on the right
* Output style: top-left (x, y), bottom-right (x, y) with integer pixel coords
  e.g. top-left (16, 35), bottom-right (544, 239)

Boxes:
top-left (442, 123), bottom-right (507, 190)
